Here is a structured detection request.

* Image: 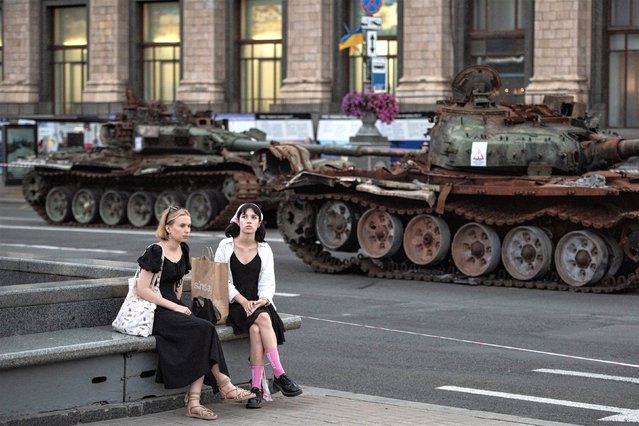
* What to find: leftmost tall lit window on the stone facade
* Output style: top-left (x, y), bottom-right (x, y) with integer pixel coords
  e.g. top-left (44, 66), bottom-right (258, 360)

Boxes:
top-left (52, 6), bottom-right (88, 114)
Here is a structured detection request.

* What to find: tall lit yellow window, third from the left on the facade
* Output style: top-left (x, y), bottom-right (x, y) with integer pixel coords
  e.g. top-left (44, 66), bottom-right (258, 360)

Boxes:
top-left (239, 0), bottom-right (283, 112)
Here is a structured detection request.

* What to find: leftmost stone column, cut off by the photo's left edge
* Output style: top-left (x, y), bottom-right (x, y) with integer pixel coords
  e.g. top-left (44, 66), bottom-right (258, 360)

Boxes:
top-left (0, 0), bottom-right (41, 103)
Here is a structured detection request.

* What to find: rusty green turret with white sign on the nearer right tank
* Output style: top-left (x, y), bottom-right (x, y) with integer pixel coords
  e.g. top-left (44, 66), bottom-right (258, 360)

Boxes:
top-left (429, 66), bottom-right (639, 175)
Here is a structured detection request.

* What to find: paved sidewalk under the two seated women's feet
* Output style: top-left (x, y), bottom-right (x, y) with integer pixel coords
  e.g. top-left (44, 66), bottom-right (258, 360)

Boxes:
top-left (85, 387), bottom-right (566, 426)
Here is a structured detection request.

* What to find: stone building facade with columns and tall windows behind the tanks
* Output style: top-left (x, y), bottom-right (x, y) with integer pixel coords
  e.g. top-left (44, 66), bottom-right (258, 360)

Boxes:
top-left (0, 0), bottom-right (639, 134)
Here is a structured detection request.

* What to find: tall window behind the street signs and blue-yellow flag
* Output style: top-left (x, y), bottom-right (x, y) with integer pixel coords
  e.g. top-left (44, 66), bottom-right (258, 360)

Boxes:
top-left (349, 0), bottom-right (399, 94)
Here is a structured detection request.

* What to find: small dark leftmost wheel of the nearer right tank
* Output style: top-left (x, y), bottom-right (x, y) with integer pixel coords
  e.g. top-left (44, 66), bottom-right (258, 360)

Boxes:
top-left (277, 195), bottom-right (315, 244)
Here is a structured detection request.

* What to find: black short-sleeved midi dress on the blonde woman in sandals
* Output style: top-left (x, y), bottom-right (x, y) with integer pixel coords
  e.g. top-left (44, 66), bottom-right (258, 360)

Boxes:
top-left (138, 243), bottom-right (228, 389)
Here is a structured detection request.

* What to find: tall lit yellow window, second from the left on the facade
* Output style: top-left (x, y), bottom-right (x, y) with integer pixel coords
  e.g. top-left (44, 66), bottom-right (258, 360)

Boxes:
top-left (142, 1), bottom-right (181, 103)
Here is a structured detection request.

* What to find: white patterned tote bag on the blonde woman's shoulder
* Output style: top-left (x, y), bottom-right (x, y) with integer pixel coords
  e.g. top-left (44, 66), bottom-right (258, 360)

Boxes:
top-left (111, 244), bottom-right (164, 337)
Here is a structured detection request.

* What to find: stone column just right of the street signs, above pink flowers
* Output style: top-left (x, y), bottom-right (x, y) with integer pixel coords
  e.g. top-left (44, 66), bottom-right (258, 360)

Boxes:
top-left (396, 0), bottom-right (454, 105)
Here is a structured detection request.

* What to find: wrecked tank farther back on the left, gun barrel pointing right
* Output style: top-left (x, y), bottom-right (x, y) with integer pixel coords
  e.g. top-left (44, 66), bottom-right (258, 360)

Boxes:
top-left (23, 94), bottom-right (420, 229)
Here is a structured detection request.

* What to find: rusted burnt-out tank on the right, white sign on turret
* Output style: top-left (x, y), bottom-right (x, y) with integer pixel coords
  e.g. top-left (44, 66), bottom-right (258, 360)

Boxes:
top-left (277, 66), bottom-right (639, 293)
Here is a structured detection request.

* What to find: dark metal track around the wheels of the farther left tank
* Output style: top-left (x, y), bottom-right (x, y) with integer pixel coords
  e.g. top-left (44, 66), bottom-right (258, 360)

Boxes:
top-left (24, 171), bottom-right (261, 230)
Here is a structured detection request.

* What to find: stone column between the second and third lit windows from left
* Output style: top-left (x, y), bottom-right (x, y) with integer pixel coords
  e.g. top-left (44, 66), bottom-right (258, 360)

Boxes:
top-left (176, 0), bottom-right (226, 105)
